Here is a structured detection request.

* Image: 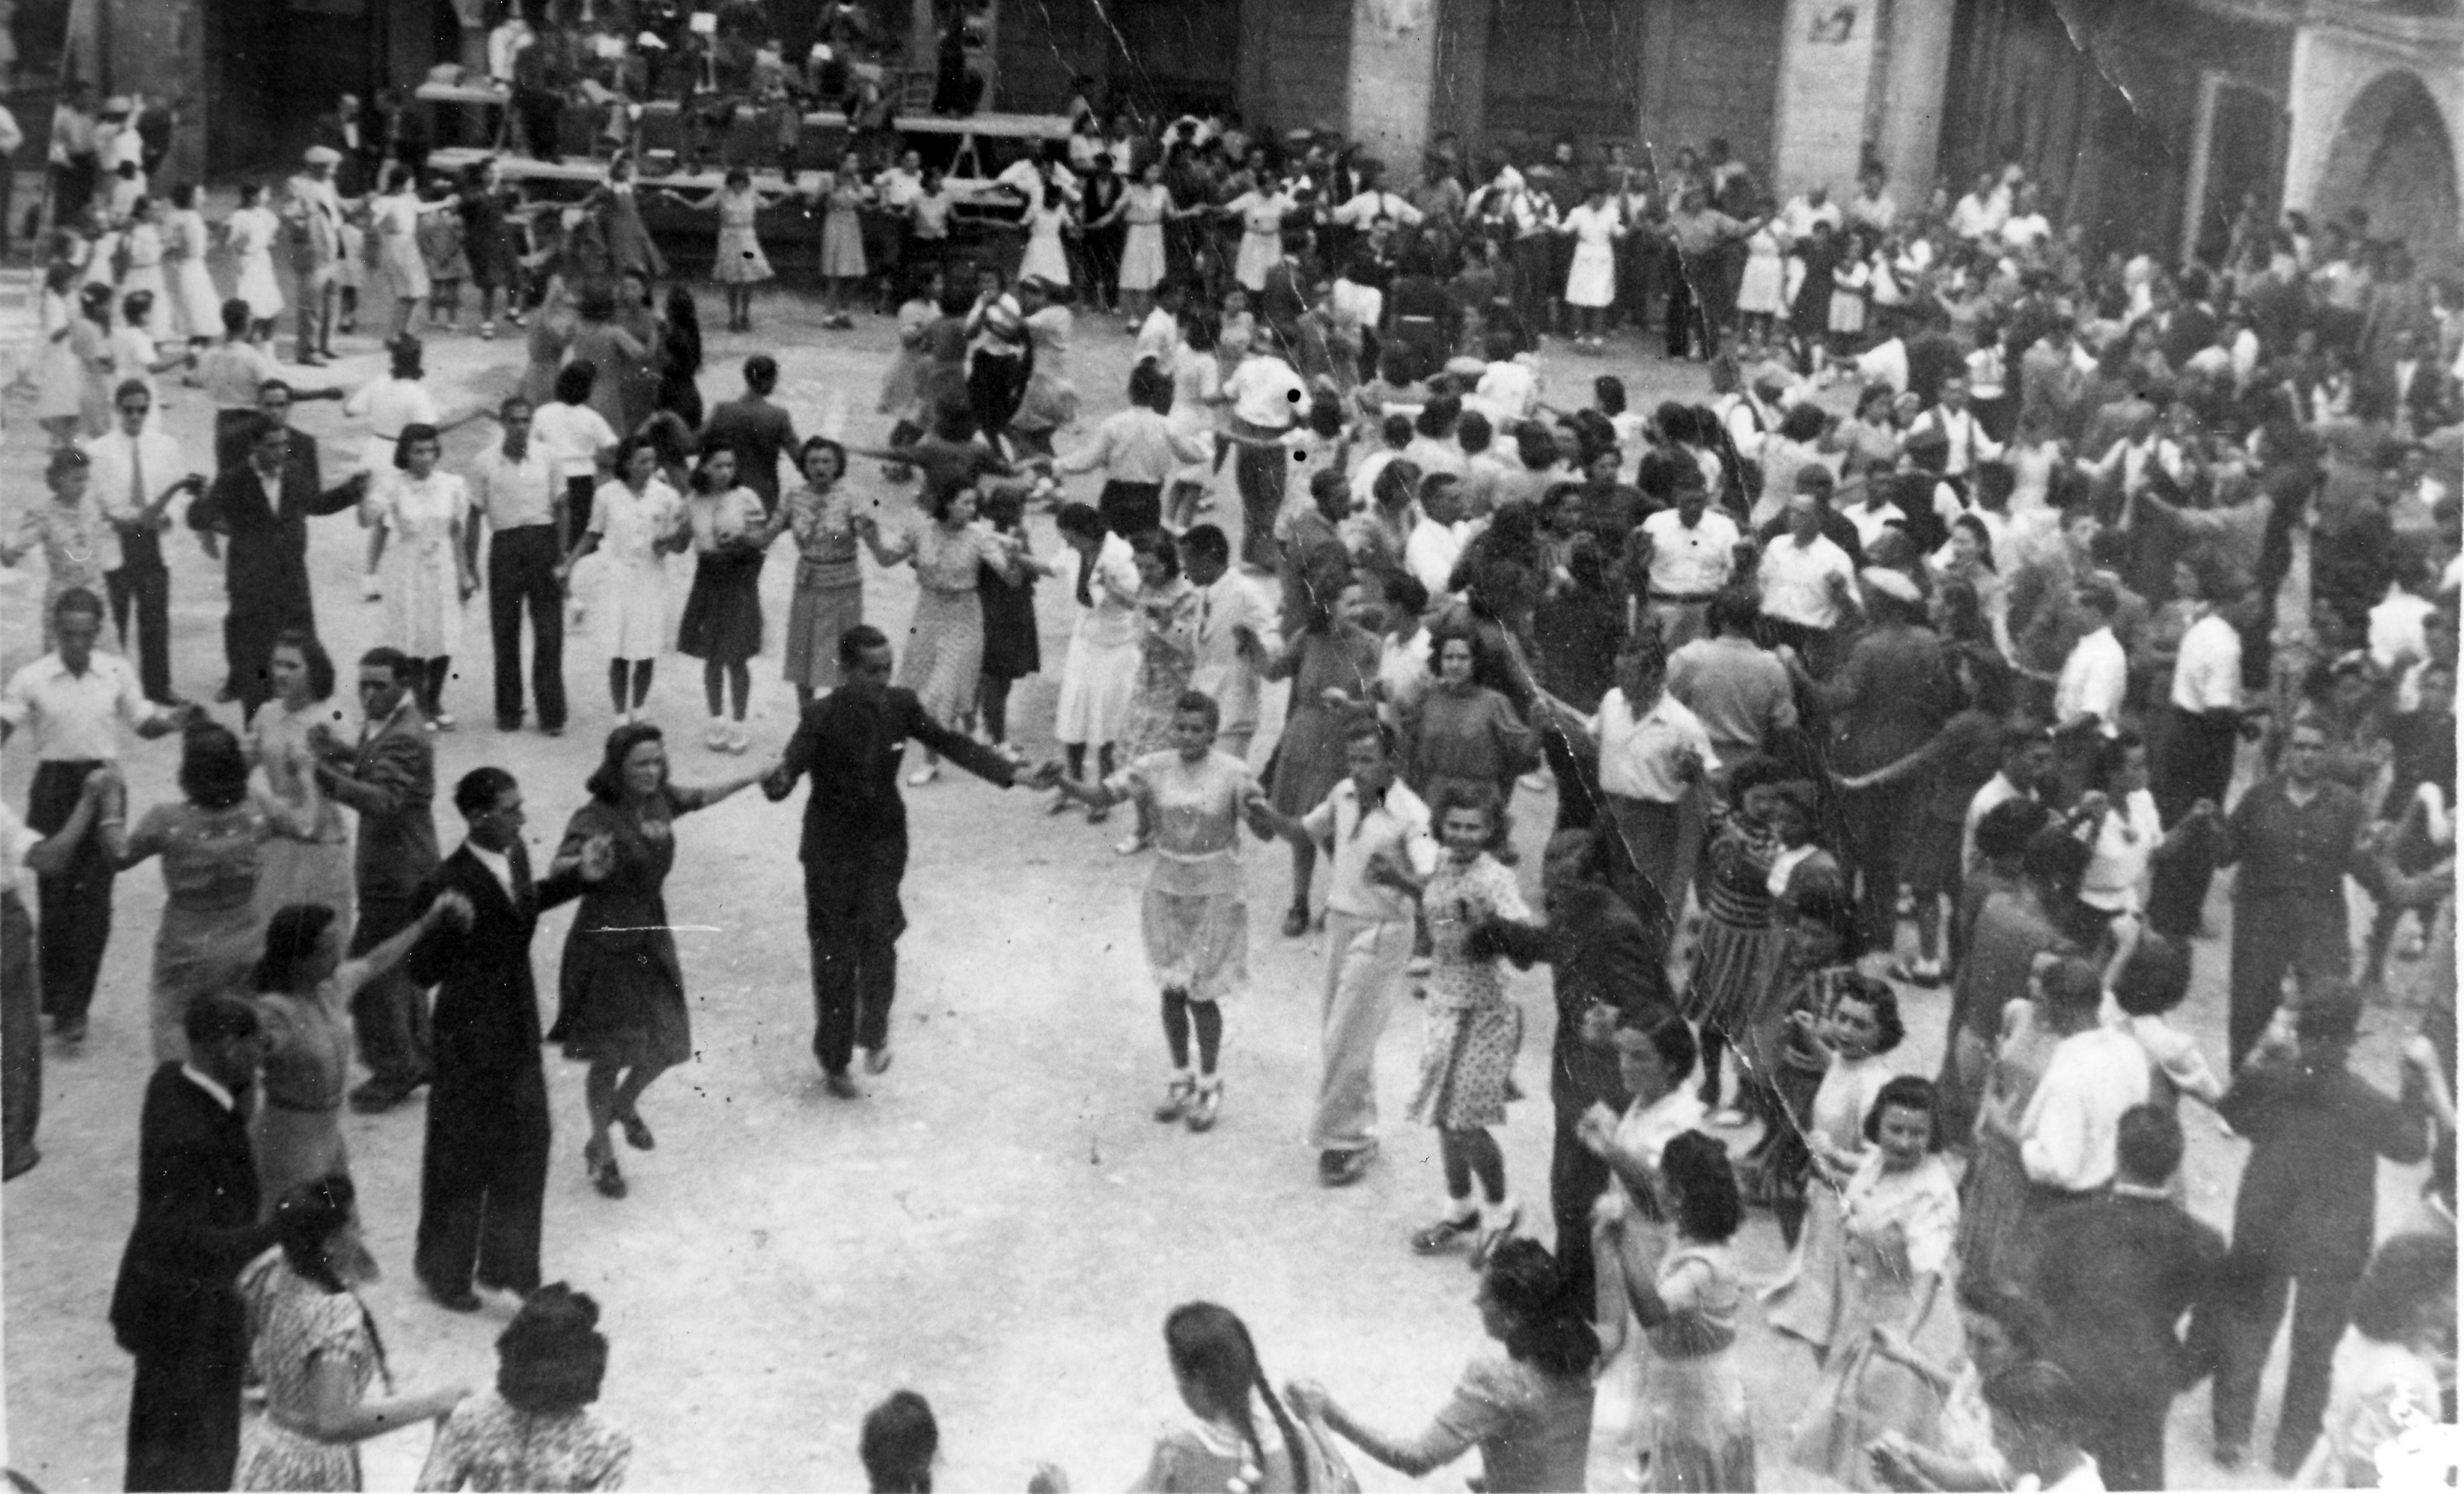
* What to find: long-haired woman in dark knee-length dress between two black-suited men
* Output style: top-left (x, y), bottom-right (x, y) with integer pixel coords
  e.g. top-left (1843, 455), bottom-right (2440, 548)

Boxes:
top-left (547, 722), bottom-right (769, 1198)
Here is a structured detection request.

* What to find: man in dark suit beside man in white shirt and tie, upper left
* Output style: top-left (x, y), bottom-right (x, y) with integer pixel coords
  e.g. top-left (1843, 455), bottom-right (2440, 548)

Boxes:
top-left (187, 409), bottom-right (367, 715)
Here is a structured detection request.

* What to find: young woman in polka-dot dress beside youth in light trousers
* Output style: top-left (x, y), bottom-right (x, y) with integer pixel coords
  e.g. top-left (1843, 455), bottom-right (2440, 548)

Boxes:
top-left (1412, 784), bottom-right (1535, 1267)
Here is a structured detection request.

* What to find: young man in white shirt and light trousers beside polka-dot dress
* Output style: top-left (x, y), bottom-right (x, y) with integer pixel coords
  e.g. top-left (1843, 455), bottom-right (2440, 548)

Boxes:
top-left (1252, 715), bottom-right (1437, 1188)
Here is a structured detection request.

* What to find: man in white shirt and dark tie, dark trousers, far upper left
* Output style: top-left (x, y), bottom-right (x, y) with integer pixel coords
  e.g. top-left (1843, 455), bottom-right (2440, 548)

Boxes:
top-left (86, 380), bottom-right (205, 705)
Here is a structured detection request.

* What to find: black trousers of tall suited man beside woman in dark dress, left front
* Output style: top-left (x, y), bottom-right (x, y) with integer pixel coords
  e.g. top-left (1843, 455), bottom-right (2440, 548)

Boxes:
top-left (411, 1055), bottom-right (549, 1297)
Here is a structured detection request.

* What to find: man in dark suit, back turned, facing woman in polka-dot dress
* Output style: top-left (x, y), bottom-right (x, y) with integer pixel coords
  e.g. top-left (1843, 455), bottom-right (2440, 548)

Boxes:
top-left (1481, 831), bottom-right (1675, 1311)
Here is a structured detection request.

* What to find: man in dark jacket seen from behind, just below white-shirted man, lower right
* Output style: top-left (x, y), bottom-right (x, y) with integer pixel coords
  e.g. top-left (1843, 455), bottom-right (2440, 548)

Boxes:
top-left (2035, 1105), bottom-right (2225, 1489)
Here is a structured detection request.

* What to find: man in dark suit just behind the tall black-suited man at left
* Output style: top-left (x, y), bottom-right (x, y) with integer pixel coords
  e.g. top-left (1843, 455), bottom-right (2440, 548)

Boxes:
top-left (308, 648), bottom-right (436, 1114)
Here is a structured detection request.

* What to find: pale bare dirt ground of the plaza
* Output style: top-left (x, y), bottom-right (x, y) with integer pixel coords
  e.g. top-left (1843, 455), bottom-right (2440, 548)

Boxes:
top-left (0, 293), bottom-right (2419, 1489)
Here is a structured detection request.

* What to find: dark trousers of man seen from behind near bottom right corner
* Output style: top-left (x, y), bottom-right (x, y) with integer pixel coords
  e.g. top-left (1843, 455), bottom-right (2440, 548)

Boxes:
top-left (2207, 1258), bottom-right (2363, 1489)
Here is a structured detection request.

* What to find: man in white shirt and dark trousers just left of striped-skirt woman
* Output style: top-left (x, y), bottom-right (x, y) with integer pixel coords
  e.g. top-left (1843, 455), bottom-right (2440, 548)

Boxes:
top-left (1590, 633), bottom-right (1720, 927)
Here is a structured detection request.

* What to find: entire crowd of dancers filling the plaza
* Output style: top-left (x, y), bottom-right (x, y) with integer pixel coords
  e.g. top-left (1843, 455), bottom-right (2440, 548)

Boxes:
top-left (0, 5), bottom-right (2464, 1489)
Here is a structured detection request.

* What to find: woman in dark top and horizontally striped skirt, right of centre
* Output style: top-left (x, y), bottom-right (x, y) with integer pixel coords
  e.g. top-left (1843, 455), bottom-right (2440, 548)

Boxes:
top-left (1683, 757), bottom-right (1789, 1124)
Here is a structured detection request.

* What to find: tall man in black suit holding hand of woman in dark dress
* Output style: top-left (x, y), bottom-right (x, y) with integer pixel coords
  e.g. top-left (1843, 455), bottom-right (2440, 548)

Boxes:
top-left (411, 767), bottom-right (606, 1311)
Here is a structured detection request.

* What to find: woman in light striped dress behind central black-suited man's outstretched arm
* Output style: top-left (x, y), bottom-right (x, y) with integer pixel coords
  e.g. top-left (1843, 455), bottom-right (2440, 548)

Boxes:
top-left (855, 483), bottom-right (1018, 786)
